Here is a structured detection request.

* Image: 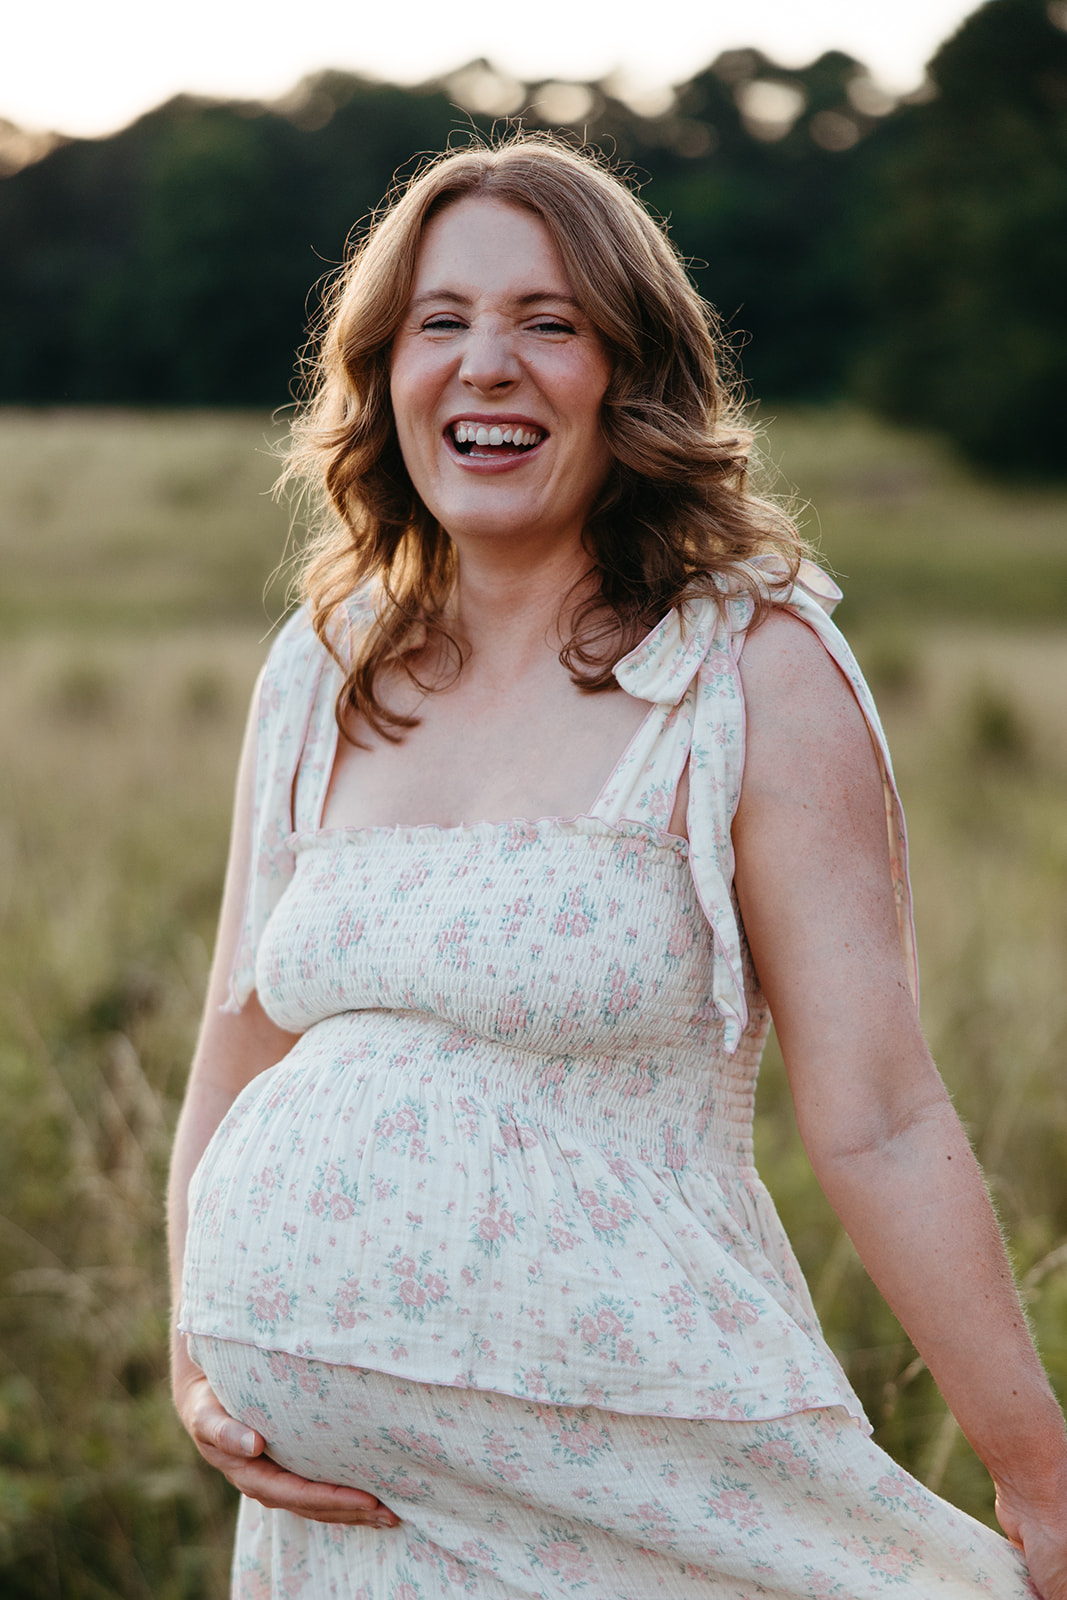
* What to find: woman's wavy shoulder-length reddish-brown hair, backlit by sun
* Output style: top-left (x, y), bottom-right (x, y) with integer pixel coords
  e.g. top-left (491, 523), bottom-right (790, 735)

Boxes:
top-left (282, 133), bottom-right (800, 738)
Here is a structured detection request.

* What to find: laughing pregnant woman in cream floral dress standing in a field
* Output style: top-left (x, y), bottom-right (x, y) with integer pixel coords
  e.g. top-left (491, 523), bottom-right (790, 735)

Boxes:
top-left (171, 139), bottom-right (1067, 1600)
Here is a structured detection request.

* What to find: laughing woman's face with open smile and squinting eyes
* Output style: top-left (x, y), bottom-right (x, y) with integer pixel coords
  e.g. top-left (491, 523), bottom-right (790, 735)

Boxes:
top-left (392, 197), bottom-right (611, 560)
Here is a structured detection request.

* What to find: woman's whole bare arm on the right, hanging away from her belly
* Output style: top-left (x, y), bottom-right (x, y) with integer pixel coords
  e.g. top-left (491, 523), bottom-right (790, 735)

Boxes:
top-left (734, 611), bottom-right (1067, 1600)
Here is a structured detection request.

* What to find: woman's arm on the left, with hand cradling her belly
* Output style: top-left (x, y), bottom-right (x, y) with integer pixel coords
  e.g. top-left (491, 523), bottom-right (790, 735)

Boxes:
top-left (168, 694), bottom-right (398, 1526)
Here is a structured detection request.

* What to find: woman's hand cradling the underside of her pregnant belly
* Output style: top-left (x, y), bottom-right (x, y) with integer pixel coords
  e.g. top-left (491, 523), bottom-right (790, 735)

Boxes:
top-left (174, 1365), bottom-right (400, 1528)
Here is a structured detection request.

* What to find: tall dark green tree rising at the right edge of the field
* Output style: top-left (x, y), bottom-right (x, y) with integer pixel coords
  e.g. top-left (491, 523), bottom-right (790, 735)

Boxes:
top-left (861, 0), bottom-right (1067, 477)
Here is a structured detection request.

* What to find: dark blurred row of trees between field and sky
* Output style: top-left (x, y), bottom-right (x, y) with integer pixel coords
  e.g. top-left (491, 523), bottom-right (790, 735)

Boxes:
top-left (0, 0), bottom-right (1067, 475)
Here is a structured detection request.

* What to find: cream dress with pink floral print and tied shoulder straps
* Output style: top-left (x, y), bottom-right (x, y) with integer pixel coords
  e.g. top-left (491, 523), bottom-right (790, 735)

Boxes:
top-left (182, 565), bottom-right (1029, 1600)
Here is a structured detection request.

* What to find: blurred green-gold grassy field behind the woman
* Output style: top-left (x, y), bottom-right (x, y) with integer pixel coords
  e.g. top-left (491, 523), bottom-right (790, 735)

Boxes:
top-left (0, 413), bottom-right (1067, 1600)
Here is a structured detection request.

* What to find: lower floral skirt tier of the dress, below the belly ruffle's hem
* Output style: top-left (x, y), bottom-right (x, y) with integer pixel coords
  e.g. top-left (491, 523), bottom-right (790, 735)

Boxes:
top-left (190, 1338), bottom-right (1033, 1600)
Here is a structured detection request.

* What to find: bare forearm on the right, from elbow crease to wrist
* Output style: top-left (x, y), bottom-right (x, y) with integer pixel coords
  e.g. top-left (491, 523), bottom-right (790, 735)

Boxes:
top-left (813, 1099), bottom-right (1067, 1493)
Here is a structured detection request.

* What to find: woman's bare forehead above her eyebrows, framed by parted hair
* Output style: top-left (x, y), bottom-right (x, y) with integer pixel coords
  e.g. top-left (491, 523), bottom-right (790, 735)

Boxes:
top-left (413, 195), bottom-right (573, 298)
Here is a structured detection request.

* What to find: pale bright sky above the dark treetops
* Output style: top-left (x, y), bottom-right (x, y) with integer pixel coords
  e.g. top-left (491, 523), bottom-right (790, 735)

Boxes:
top-left (0, 0), bottom-right (976, 134)
